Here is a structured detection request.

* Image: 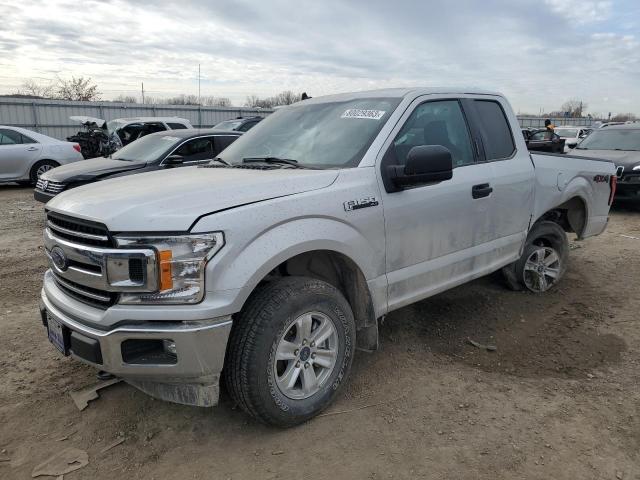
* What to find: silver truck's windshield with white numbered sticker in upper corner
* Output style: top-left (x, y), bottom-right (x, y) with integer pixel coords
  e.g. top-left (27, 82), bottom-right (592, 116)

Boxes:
top-left (220, 98), bottom-right (401, 168)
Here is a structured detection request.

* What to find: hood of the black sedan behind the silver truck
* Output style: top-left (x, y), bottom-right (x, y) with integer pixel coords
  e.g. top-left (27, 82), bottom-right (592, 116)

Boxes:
top-left (42, 157), bottom-right (146, 184)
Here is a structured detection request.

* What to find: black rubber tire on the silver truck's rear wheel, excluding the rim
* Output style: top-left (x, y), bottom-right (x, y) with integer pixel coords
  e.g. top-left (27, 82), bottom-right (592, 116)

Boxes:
top-left (502, 221), bottom-right (569, 293)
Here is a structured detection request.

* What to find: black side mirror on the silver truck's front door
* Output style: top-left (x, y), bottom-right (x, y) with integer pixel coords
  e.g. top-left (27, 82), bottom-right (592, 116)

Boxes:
top-left (387, 145), bottom-right (453, 188)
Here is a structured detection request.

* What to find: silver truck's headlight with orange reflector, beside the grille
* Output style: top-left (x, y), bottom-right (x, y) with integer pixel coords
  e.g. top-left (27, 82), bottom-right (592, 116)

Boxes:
top-left (116, 232), bottom-right (224, 304)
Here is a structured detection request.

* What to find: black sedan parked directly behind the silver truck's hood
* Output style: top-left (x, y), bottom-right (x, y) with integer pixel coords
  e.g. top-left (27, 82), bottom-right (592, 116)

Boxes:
top-left (33, 129), bottom-right (242, 203)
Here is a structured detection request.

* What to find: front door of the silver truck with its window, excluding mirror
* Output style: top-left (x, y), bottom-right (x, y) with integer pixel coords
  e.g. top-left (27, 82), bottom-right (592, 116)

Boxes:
top-left (379, 97), bottom-right (495, 311)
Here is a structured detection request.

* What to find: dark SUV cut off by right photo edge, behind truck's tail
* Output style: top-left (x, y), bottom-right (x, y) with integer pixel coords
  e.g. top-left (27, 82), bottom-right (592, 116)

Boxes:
top-left (573, 123), bottom-right (640, 202)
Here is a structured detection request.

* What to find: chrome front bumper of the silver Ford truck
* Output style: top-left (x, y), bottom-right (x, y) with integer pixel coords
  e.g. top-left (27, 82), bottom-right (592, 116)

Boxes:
top-left (40, 289), bottom-right (231, 406)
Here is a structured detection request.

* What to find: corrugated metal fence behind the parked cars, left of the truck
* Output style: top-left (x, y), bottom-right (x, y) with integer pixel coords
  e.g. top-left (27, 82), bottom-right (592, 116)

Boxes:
top-left (0, 97), bottom-right (272, 140)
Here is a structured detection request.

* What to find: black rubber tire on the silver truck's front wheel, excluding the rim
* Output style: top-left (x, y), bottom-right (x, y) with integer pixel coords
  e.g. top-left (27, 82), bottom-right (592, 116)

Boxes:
top-left (223, 277), bottom-right (356, 427)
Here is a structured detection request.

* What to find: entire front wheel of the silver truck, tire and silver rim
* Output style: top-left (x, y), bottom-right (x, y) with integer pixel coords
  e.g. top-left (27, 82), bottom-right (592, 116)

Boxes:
top-left (224, 277), bottom-right (355, 427)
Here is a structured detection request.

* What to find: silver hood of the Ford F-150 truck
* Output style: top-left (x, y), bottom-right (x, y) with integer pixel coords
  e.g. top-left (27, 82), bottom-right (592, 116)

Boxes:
top-left (47, 167), bottom-right (338, 232)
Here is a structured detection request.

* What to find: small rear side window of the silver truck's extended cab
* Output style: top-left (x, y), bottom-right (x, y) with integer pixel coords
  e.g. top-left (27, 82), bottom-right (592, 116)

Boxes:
top-left (474, 100), bottom-right (515, 160)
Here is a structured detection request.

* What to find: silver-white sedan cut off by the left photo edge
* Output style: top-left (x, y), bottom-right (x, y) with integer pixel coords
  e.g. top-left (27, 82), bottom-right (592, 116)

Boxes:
top-left (0, 125), bottom-right (83, 184)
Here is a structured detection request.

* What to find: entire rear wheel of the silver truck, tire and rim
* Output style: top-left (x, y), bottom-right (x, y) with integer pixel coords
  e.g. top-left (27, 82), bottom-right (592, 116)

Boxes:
top-left (502, 222), bottom-right (569, 293)
